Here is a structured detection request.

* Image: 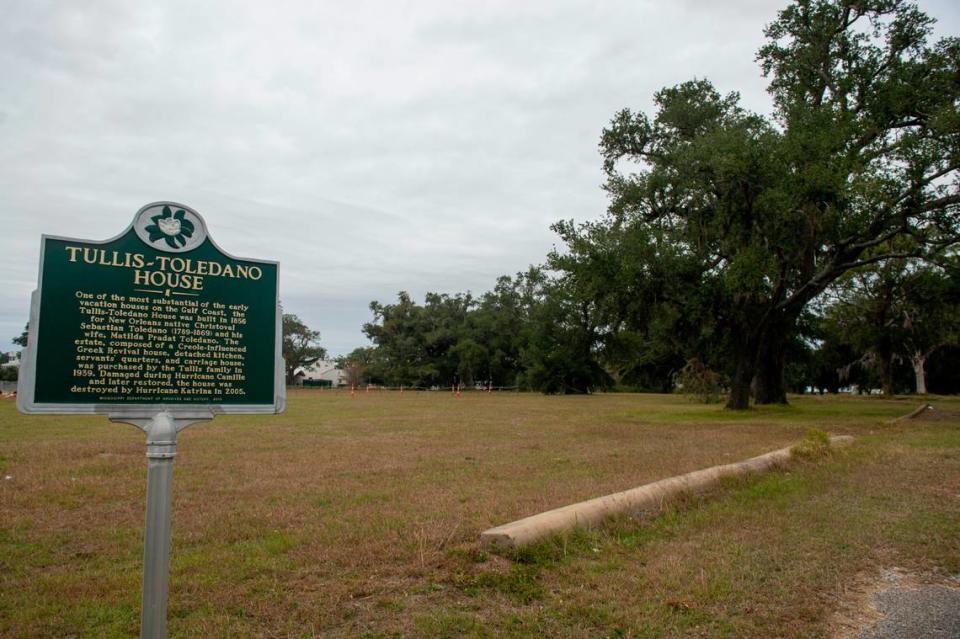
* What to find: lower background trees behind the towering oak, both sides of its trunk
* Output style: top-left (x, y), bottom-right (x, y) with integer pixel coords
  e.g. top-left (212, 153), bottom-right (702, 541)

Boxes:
top-left (339, 255), bottom-right (960, 394)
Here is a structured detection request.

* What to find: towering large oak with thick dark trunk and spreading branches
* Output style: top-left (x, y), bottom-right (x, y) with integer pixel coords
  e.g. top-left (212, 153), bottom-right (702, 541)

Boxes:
top-left (556, 0), bottom-right (960, 409)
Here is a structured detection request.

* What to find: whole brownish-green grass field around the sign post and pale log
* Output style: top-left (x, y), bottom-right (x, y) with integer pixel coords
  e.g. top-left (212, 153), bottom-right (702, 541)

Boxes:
top-left (0, 391), bottom-right (960, 638)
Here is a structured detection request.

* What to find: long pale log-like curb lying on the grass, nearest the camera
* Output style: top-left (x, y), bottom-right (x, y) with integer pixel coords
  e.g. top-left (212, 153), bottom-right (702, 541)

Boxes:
top-left (480, 435), bottom-right (853, 550)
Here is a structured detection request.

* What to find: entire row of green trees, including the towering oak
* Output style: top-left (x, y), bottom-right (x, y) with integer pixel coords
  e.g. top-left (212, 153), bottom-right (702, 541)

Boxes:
top-left (343, 0), bottom-right (960, 409)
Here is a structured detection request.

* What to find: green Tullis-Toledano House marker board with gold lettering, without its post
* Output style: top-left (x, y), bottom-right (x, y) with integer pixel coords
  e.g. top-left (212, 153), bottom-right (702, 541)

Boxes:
top-left (18, 202), bottom-right (284, 413)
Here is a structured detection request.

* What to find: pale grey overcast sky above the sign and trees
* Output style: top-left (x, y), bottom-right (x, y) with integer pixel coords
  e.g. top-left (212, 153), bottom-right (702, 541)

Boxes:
top-left (0, 0), bottom-right (960, 354)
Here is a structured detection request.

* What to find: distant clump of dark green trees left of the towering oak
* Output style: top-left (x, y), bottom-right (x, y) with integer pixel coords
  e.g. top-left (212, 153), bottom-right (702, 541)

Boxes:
top-left (360, 268), bottom-right (609, 393)
